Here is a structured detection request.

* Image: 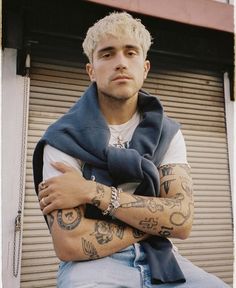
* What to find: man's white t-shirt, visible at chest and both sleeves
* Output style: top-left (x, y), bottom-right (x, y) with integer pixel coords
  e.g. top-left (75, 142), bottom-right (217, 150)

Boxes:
top-left (43, 112), bottom-right (187, 179)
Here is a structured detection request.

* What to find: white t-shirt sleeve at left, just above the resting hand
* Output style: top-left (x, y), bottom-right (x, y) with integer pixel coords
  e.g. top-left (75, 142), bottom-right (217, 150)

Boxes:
top-left (43, 145), bottom-right (82, 180)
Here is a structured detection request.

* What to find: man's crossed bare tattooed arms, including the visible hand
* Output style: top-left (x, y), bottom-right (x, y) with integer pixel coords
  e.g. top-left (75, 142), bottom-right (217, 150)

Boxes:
top-left (39, 163), bottom-right (193, 261)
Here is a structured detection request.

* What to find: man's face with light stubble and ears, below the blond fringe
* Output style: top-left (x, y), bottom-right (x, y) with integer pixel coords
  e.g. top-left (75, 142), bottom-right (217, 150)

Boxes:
top-left (87, 36), bottom-right (150, 100)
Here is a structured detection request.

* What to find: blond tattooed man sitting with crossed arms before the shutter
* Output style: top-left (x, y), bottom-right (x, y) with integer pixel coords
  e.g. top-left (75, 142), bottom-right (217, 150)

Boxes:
top-left (34, 12), bottom-right (227, 288)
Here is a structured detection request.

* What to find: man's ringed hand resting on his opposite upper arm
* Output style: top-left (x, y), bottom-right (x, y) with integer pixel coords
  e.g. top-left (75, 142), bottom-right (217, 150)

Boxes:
top-left (38, 162), bottom-right (96, 214)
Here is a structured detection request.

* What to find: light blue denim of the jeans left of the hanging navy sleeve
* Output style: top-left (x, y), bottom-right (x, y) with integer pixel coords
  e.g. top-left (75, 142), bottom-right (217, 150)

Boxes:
top-left (57, 244), bottom-right (152, 288)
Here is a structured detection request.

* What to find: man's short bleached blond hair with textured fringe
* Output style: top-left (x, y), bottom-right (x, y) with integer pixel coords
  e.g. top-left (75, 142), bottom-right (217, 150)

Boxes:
top-left (82, 12), bottom-right (152, 63)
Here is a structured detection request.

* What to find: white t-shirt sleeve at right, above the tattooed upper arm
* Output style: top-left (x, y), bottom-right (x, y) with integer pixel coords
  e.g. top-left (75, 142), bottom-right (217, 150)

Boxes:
top-left (160, 130), bottom-right (188, 166)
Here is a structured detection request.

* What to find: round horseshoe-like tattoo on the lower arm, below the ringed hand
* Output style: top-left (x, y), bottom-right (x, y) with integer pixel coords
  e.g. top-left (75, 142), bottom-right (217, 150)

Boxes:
top-left (57, 207), bottom-right (81, 230)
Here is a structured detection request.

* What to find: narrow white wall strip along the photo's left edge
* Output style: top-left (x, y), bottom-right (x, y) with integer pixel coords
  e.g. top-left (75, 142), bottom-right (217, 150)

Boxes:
top-left (2, 49), bottom-right (24, 288)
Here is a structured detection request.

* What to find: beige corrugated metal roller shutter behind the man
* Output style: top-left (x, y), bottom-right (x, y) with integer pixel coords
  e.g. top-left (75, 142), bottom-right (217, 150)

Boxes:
top-left (21, 59), bottom-right (233, 288)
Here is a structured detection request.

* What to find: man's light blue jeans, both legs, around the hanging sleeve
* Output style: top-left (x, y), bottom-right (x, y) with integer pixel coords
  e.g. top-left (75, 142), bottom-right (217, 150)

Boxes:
top-left (57, 244), bottom-right (229, 288)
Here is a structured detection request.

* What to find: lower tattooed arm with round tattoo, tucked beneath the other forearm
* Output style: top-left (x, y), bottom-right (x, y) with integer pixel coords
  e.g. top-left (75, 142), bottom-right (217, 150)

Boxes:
top-left (47, 207), bottom-right (148, 261)
